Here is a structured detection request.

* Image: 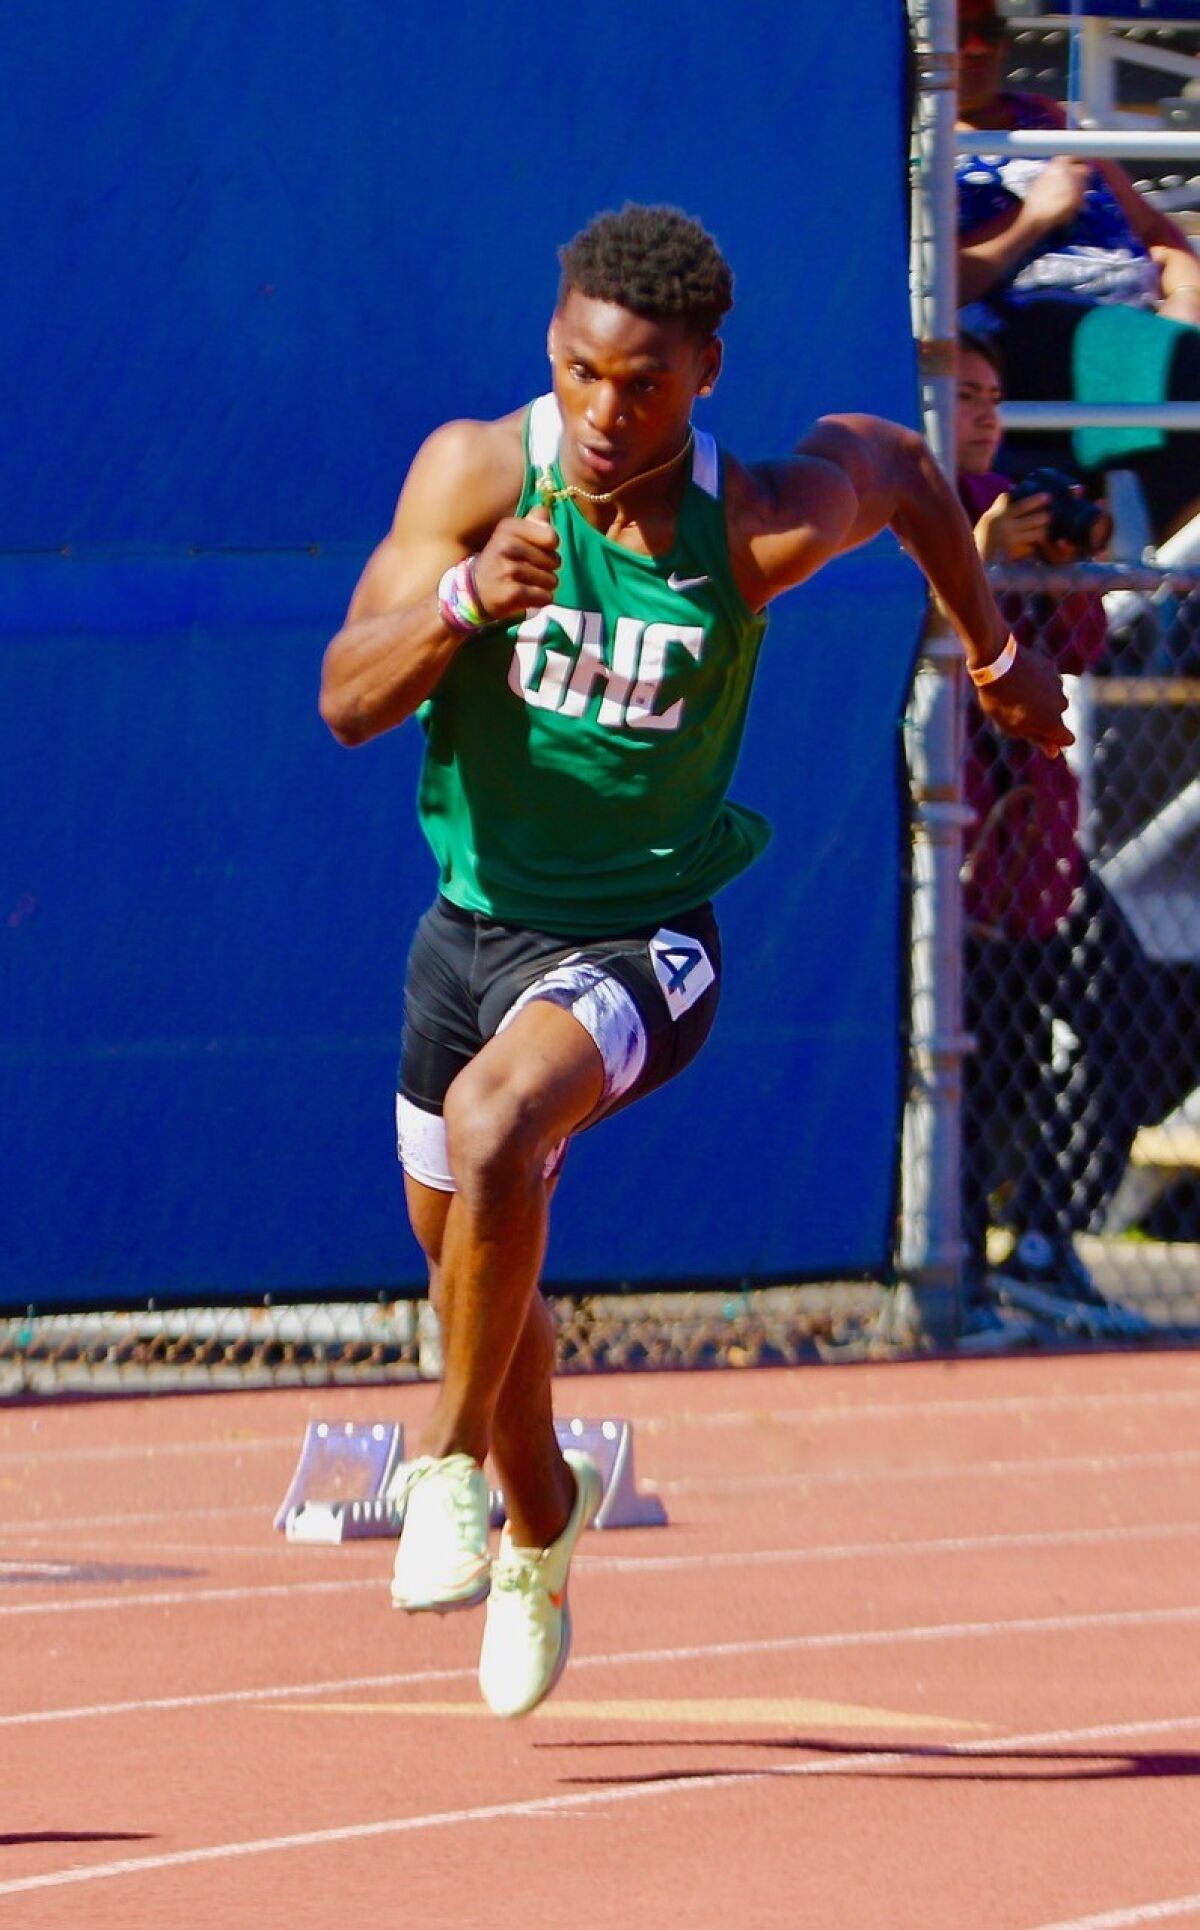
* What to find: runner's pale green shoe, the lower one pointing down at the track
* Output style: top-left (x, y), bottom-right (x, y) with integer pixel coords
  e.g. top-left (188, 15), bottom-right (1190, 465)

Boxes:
top-left (478, 1449), bottom-right (604, 1716)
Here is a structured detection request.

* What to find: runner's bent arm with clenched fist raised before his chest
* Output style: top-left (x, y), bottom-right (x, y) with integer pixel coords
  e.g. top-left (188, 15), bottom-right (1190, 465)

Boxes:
top-left (320, 415), bottom-right (558, 745)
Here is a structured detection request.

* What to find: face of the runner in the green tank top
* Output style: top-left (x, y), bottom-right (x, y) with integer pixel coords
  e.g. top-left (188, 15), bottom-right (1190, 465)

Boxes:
top-left (550, 288), bottom-right (722, 492)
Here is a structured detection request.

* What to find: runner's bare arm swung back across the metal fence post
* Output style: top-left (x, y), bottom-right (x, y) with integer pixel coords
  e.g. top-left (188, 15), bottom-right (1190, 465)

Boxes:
top-left (729, 415), bottom-right (1073, 757)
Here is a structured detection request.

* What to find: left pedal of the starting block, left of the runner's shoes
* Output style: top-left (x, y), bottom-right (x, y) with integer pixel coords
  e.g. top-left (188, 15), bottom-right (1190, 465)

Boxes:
top-left (274, 1420), bottom-right (403, 1542)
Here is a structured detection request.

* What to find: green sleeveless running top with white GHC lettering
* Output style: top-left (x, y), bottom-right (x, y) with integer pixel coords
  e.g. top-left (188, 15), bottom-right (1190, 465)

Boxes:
top-left (417, 396), bottom-right (770, 936)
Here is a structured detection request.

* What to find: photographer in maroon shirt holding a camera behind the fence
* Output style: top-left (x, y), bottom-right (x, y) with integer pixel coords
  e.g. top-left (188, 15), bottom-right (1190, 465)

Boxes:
top-left (955, 336), bottom-right (1150, 1339)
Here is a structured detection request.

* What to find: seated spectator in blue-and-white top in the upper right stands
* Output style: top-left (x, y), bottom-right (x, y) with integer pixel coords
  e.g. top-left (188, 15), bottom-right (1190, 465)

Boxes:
top-left (957, 0), bottom-right (1200, 540)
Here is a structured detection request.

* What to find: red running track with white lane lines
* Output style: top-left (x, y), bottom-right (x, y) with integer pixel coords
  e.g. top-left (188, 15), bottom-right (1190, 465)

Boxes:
top-left (0, 1353), bottom-right (1200, 1930)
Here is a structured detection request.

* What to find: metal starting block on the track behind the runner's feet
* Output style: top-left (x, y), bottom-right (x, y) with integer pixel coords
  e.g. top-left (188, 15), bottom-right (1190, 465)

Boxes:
top-left (274, 1420), bottom-right (668, 1542)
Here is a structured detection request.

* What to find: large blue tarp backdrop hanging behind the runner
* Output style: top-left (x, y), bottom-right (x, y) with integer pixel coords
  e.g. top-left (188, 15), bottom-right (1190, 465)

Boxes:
top-left (0, 0), bottom-right (922, 1307)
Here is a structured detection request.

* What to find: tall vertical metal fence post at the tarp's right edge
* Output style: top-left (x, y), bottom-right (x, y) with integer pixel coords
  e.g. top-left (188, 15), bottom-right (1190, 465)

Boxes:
top-left (895, 0), bottom-right (968, 1341)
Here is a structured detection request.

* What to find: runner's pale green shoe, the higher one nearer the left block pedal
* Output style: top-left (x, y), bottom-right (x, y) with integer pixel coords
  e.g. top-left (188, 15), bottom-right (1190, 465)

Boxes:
top-left (392, 1453), bottom-right (492, 1613)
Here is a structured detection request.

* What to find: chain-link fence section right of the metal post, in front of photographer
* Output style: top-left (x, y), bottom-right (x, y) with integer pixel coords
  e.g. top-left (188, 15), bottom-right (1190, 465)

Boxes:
top-left (963, 564), bottom-right (1200, 1337)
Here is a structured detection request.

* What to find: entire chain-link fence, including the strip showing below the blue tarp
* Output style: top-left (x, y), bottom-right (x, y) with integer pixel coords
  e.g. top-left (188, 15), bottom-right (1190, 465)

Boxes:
top-left (0, 564), bottom-right (1200, 1395)
